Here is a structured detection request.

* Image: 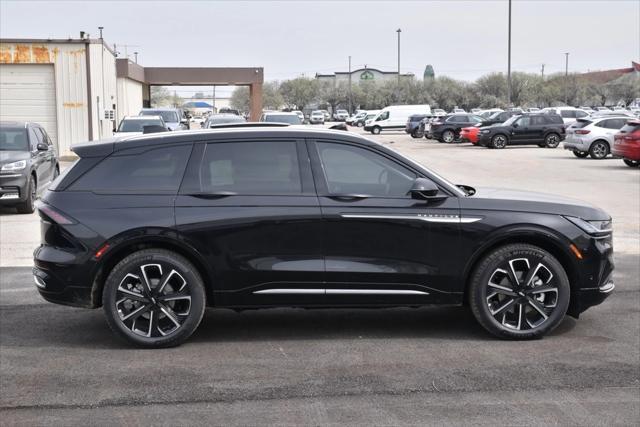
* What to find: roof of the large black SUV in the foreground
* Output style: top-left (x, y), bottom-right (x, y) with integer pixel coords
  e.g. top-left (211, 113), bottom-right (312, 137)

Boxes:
top-left (71, 124), bottom-right (379, 157)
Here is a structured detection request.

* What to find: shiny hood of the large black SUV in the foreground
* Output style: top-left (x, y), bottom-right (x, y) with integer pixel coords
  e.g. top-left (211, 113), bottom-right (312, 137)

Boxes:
top-left (469, 187), bottom-right (611, 221)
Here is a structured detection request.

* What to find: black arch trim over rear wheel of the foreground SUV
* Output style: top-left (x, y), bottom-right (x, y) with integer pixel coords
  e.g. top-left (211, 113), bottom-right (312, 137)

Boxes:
top-left (91, 236), bottom-right (213, 307)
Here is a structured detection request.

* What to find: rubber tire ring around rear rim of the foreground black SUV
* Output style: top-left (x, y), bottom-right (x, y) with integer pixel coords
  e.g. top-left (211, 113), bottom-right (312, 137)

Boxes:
top-left (102, 249), bottom-right (206, 348)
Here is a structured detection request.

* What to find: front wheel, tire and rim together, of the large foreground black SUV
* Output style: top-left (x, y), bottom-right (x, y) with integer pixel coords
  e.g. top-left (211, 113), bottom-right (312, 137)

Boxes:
top-left (469, 244), bottom-right (571, 339)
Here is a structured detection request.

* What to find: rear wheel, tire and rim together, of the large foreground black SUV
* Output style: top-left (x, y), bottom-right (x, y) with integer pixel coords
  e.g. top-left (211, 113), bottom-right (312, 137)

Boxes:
top-left (102, 249), bottom-right (206, 348)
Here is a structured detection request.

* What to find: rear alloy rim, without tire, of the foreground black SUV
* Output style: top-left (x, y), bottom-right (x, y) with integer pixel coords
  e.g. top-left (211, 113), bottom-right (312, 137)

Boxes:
top-left (115, 264), bottom-right (191, 338)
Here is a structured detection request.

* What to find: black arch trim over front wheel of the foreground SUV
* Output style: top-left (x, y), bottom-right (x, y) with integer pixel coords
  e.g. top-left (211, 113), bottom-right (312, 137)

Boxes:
top-left (463, 229), bottom-right (580, 317)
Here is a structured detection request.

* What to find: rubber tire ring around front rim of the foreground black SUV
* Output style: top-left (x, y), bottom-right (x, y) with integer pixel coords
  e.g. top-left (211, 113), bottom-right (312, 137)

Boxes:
top-left (469, 245), bottom-right (571, 339)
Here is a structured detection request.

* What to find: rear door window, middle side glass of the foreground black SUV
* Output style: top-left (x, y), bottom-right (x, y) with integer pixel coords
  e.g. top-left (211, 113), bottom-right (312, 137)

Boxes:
top-left (200, 141), bottom-right (302, 195)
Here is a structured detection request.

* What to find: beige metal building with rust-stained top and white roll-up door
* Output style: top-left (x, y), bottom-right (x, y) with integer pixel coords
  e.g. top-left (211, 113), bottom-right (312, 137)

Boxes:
top-left (0, 39), bottom-right (117, 156)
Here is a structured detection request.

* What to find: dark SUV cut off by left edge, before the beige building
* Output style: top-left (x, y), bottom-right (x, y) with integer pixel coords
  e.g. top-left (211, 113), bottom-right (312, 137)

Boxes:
top-left (0, 122), bottom-right (60, 213)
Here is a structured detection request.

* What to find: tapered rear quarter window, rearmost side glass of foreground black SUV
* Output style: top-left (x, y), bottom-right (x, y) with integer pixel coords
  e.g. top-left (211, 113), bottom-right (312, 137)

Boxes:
top-left (71, 145), bottom-right (191, 194)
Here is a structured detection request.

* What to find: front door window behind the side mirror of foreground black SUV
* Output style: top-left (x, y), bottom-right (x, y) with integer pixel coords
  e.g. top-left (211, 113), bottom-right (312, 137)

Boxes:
top-left (318, 142), bottom-right (416, 197)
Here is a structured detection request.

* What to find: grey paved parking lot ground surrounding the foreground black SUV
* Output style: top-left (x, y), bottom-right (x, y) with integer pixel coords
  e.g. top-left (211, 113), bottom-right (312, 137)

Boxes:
top-left (0, 131), bottom-right (640, 425)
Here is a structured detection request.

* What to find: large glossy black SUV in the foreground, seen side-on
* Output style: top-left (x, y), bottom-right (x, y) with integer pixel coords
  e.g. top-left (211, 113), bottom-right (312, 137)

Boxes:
top-left (33, 126), bottom-right (614, 347)
